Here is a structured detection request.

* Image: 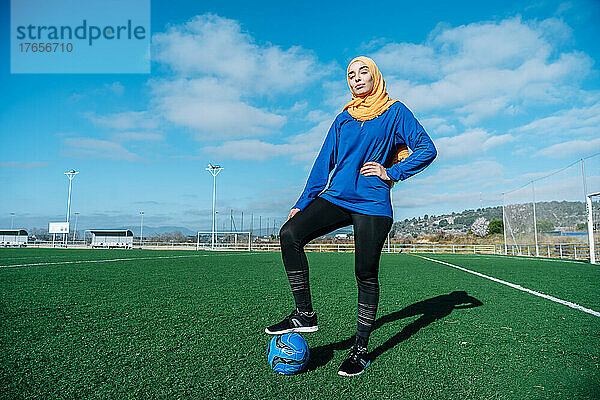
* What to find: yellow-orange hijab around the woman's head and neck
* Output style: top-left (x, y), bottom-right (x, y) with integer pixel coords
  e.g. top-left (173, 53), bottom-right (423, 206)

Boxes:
top-left (344, 56), bottom-right (409, 164)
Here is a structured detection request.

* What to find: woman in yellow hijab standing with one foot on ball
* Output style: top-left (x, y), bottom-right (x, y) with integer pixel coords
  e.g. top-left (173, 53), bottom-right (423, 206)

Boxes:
top-left (265, 57), bottom-right (437, 376)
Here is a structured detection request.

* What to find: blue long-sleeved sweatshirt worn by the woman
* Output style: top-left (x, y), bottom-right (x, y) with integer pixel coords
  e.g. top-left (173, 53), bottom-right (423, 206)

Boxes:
top-left (292, 101), bottom-right (437, 218)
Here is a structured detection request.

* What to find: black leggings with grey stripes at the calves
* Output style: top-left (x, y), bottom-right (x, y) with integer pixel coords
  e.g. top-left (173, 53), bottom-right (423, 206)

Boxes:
top-left (279, 197), bottom-right (392, 341)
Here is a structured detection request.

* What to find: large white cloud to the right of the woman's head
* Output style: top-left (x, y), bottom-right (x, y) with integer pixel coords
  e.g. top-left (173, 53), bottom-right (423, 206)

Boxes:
top-left (372, 17), bottom-right (592, 125)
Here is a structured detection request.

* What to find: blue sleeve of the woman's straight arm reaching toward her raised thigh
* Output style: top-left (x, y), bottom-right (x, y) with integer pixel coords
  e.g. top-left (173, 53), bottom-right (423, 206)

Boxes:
top-left (288, 119), bottom-right (339, 211)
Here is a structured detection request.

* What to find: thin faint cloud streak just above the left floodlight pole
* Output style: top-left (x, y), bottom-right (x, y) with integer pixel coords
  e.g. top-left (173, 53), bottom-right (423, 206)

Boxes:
top-left (63, 137), bottom-right (140, 161)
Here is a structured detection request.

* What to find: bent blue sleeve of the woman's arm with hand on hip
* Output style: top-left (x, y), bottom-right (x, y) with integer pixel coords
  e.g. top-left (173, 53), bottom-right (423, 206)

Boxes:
top-left (386, 105), bottom-right (437, 181)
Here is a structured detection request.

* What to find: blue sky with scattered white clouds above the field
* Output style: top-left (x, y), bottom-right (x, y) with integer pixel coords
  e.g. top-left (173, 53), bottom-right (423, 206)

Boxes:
top-left (0, 0), bottom-right (600, 230)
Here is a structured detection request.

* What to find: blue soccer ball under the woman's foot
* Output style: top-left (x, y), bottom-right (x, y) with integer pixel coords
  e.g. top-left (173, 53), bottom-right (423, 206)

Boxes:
top-left (267, 333), bottom-right (310, 375)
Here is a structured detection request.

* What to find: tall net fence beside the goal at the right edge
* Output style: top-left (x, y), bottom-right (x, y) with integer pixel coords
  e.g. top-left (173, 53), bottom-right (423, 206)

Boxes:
top-left (502, 153), bottom-right (600, 259)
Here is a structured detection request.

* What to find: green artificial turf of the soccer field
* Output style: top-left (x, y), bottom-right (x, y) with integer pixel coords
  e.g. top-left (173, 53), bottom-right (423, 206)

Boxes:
top-left (0, 249), bottom-right (600, 399)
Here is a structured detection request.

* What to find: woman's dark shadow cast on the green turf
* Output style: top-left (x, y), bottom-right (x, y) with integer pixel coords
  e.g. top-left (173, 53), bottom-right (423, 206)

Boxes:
top-left (305, 291), bottom-right (483, 371)
